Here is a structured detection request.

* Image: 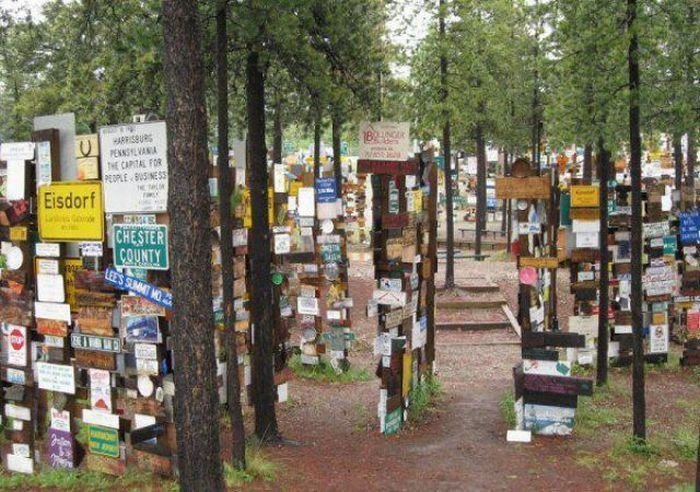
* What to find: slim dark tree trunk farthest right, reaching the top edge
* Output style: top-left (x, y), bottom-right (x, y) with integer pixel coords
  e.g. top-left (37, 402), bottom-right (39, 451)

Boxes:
top-left (627, 0), bottom-right (646, 440)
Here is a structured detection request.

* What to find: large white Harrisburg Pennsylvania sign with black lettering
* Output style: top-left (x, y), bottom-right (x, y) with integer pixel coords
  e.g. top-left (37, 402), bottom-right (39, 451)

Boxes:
top-left (100, 121), bottom-right (168, 214)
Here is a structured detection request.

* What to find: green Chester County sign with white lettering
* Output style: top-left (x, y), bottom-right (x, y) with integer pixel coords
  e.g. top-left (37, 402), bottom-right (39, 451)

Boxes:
top-left (114, 224), bottom-right (169, 270)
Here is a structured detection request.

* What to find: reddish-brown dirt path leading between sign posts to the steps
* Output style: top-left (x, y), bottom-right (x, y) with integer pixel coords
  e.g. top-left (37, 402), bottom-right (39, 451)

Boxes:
top-left (246, 263), bottom-right (700, 492)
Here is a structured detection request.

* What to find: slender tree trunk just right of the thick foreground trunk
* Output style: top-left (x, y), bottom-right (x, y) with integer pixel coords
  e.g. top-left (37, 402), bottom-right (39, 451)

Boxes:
top-left (216, 6), bottom-right (245, 470)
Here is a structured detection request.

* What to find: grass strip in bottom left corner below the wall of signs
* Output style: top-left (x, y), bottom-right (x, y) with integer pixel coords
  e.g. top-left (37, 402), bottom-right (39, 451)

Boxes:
top-left (0, 469), bottom-right (159, 491)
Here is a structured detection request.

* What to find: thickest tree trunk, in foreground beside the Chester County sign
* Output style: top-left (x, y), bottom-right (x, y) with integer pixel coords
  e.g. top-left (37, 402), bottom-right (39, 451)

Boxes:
top-left (163, 0), bottom-right (224, 490)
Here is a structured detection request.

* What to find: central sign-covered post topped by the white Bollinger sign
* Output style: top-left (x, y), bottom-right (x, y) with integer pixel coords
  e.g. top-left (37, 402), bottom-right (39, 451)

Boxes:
top-left (358, 122), bottom-right (437, 434)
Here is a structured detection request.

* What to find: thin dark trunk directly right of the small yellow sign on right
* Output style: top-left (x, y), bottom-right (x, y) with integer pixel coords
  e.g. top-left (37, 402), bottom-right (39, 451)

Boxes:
top-left (596, 137), bottom-right (610, 386)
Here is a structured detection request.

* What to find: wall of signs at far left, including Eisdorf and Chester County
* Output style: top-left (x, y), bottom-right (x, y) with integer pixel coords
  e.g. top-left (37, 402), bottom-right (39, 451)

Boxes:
top-left (0, 122), bottom-right (174, 475)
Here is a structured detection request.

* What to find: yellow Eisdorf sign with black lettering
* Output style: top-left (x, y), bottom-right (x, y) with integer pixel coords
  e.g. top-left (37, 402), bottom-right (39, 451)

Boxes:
top-left (39, 181), bottom-right (104, 242)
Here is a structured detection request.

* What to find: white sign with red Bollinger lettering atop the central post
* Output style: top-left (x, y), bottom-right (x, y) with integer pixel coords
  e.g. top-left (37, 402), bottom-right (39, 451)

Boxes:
top-left (359, 121), bottom-right (411, 162)
